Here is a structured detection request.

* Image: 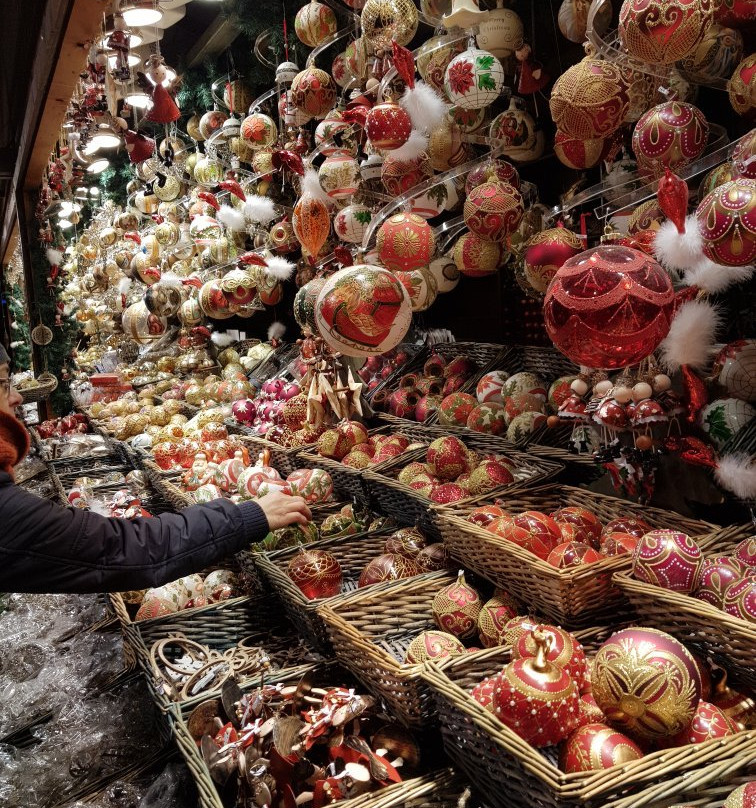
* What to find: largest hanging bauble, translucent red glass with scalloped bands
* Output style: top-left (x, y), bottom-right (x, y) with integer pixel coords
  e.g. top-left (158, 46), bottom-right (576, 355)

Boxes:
top-left (544, 245), bottom-right (675, 370)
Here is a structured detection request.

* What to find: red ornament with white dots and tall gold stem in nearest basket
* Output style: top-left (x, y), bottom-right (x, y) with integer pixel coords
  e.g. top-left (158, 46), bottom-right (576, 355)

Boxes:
top-left (494, 629), bottom-right (580, 748)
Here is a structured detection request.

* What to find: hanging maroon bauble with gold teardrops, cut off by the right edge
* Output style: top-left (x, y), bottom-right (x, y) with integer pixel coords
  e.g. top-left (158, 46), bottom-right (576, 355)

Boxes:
top-left (696, 177), bottom-right (756, 267)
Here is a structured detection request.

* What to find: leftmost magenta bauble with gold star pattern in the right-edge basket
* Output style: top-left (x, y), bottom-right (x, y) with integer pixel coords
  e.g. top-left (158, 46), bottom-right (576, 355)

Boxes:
top-left (633, 530), bottom-right (703, 592)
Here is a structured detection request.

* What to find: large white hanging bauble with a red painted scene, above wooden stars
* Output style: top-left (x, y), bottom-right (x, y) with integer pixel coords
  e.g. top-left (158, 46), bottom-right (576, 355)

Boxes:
top-left (315, 264), bottom-right (412, 357)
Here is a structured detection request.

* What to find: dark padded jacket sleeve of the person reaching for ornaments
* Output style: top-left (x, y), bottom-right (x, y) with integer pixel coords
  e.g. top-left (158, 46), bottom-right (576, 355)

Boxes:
top-left (0, 472), bottom-right (268, 593)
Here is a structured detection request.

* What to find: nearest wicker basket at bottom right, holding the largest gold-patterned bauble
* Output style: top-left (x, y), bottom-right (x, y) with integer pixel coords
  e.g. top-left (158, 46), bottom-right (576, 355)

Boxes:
top-left (420, 648), bottom-right (756, 808)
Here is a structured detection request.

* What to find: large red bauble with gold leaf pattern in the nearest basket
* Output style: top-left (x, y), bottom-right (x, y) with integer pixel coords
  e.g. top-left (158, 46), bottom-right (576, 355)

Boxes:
top-left (591, 628), bottom-right (701, 740)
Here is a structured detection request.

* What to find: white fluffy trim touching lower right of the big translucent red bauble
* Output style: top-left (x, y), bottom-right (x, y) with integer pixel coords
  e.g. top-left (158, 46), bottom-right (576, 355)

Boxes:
top-left (660, 300), bottom-right (722, 371)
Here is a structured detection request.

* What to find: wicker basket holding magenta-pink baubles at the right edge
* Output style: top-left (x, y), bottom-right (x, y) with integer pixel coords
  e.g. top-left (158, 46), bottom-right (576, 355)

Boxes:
top-left (613, 525), bottom-right (756, 696)
